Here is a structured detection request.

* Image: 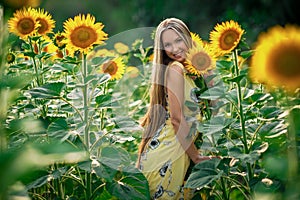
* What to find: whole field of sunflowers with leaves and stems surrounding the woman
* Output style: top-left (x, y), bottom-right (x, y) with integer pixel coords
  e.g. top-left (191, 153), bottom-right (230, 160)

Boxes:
top-left (0, 3), bottom-right (300, 200)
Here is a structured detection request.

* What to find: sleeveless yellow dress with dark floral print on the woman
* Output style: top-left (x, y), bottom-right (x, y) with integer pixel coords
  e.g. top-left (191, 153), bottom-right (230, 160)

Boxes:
top-left (139, 61), bottom-right (196, 200)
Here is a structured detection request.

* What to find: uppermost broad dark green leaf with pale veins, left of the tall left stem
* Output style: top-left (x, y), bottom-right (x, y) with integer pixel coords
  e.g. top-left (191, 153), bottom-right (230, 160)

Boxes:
top-left (29, 82), bottom-right (65, 99)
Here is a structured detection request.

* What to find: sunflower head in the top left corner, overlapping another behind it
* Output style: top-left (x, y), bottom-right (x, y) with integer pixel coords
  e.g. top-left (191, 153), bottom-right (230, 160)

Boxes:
top-left (7, 7), bottom-right (40, 39)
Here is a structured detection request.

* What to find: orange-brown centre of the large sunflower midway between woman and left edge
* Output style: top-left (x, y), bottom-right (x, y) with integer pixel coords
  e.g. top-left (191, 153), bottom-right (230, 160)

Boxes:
top-left (71, 26), bottom-right (97, 49)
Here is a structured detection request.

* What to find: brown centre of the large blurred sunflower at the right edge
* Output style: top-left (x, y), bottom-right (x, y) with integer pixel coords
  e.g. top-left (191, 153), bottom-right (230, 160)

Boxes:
top-left (270, 45), bottom-right (300, 79)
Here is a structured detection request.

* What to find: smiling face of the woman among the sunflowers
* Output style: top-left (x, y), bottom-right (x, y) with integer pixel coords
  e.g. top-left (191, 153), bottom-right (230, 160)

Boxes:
top-left (161, 29), bottom-right (188, 62)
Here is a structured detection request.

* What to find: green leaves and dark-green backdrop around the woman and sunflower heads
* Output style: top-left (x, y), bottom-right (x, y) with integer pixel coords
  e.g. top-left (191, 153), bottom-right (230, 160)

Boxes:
top-left (0, 0), bottom-right (300, 199)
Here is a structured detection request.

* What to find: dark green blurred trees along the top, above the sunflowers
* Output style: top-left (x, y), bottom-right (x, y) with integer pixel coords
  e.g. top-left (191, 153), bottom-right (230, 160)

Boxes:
top-left (0, 0), bottom-right (300, 44)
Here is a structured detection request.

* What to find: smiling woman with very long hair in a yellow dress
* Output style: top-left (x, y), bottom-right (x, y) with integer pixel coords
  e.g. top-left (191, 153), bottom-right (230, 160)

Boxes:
top-left (137, 18), bottom-right (210, 199)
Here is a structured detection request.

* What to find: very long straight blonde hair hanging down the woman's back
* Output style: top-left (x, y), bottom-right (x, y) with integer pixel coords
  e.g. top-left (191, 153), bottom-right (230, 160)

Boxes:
top-left (139, 18), bottom-right (192, 156)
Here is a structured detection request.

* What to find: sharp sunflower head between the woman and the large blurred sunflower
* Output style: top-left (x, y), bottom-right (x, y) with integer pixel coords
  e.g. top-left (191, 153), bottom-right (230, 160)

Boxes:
top-left (210, 20), bottom-right (244, 56)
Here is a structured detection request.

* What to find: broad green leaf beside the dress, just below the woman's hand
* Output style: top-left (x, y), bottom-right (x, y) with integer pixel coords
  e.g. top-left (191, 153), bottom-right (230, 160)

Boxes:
top-left (185, 158), bottom-right (223, 189)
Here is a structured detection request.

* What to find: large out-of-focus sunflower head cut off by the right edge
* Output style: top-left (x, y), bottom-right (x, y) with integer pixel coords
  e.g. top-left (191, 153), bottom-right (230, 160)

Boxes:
top-left (249, 25), bottom-right (300, 90)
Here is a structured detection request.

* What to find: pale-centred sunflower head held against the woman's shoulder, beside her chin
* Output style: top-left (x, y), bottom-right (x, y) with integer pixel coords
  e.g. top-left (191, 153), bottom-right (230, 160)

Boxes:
top-left (185, 42), bottom-right (216, 76)
